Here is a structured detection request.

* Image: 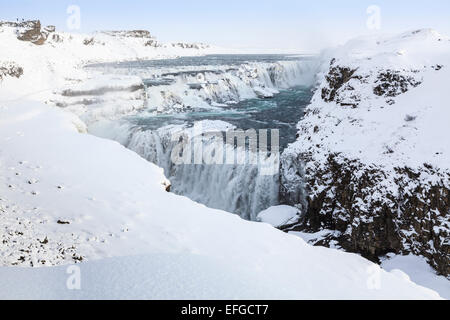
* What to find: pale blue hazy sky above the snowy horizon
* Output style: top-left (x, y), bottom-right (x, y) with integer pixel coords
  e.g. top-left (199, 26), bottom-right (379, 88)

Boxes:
top-left (0, 0), bottom-right (450, 52)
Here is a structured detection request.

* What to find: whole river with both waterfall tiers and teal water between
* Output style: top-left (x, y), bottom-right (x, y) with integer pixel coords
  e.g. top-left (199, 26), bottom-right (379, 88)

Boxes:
top-left (90, 55), bottom-right (316, 220)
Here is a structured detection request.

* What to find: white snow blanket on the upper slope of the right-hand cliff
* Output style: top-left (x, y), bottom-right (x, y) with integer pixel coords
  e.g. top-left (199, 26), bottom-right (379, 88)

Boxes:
top-left (290, 29), bottom-right (450, 169)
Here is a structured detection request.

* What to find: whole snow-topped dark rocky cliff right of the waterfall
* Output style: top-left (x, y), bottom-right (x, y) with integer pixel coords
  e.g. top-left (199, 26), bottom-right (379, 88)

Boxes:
top-left (281, 30), bottom-right (450, 276)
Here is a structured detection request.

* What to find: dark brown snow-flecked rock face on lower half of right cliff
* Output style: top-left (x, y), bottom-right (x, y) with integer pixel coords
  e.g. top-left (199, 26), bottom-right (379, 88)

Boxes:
top-left (282, 154), bottom-right (450, 276)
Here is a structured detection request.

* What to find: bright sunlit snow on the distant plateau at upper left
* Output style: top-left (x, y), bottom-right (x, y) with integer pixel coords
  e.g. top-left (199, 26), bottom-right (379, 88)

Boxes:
top-left (0, 26), bottom-right (225, 100)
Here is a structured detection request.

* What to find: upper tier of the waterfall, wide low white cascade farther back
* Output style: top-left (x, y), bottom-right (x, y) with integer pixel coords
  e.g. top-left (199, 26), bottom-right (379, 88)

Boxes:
top-left (128, 60), bottom-right (318, 114)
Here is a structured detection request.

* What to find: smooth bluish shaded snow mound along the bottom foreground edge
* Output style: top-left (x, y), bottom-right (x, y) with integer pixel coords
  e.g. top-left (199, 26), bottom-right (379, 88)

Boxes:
top-left (0, 253), bottom-right (442, 300)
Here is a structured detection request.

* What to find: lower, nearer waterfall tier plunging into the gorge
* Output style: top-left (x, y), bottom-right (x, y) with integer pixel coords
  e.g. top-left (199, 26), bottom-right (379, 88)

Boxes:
top-left (127, 121), bottom-right (279, 220)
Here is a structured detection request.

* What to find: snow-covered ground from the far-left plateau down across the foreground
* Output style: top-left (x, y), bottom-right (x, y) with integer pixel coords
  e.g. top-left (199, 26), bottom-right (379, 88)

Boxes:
top-left (0, 21), bottom-right (439, 299)
